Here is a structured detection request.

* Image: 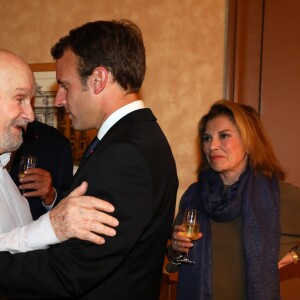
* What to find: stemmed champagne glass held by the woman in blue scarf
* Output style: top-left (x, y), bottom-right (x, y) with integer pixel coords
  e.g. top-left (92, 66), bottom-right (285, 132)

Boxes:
top-left (180, 209), bottom-right (200, 264)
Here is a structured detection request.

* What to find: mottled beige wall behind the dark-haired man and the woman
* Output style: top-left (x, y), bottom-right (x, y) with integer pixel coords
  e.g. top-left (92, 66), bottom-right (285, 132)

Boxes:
top-left (0, 0), bottom-right (226, 212)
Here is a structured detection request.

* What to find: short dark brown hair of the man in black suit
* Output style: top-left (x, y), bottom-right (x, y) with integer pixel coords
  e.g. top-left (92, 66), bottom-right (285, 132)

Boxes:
top-left (51, 19), bottom-right (146, 93)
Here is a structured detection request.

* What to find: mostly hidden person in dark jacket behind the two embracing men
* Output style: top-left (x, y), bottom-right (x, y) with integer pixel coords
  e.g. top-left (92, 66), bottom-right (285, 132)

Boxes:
top-left (9, 120), bottom-right (73, 220)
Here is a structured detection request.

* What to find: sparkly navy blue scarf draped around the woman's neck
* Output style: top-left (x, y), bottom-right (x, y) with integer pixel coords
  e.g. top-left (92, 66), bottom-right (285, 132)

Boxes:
top-left (177, 167), bottom-right (280, 300)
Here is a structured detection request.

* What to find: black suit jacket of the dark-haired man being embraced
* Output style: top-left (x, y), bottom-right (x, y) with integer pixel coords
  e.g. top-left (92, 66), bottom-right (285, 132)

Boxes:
top-left (0, 109), bottom-right (178, 300)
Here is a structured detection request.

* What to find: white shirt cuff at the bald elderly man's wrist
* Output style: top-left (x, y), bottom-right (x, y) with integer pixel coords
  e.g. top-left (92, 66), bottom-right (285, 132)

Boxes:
top-left (25, 213), bottom-right (60, 251)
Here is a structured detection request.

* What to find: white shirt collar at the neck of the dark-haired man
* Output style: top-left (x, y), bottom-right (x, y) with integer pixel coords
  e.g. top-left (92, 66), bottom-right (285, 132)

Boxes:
top-left (97, 100), bottom-right (145, 140)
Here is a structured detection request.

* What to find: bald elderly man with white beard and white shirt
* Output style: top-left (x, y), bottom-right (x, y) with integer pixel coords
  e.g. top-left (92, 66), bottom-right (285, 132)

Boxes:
top-left (0, 50), bottom-right (117, 252)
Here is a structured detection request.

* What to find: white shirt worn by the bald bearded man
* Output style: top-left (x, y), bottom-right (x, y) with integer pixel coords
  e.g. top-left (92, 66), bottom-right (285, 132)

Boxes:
top-left (0, 153), bottom-right (59, 253)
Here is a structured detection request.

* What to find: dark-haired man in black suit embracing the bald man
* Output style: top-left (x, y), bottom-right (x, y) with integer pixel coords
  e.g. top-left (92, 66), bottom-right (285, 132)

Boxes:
top-left (0, 20), bottom-right (178, 300)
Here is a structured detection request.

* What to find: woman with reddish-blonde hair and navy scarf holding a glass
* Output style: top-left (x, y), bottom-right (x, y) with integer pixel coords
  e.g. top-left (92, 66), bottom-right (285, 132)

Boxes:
top-left (168, 101), bottom-right (296, 300)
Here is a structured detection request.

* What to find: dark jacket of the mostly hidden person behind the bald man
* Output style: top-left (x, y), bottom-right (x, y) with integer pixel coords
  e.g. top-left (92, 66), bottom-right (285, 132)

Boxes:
top-left (10, 121), bottom-right (73, 220)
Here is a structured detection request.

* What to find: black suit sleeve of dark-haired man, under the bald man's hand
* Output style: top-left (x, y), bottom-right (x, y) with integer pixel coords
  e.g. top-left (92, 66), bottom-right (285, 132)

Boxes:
top-left (0, 143), bottom-right (153, 299)
